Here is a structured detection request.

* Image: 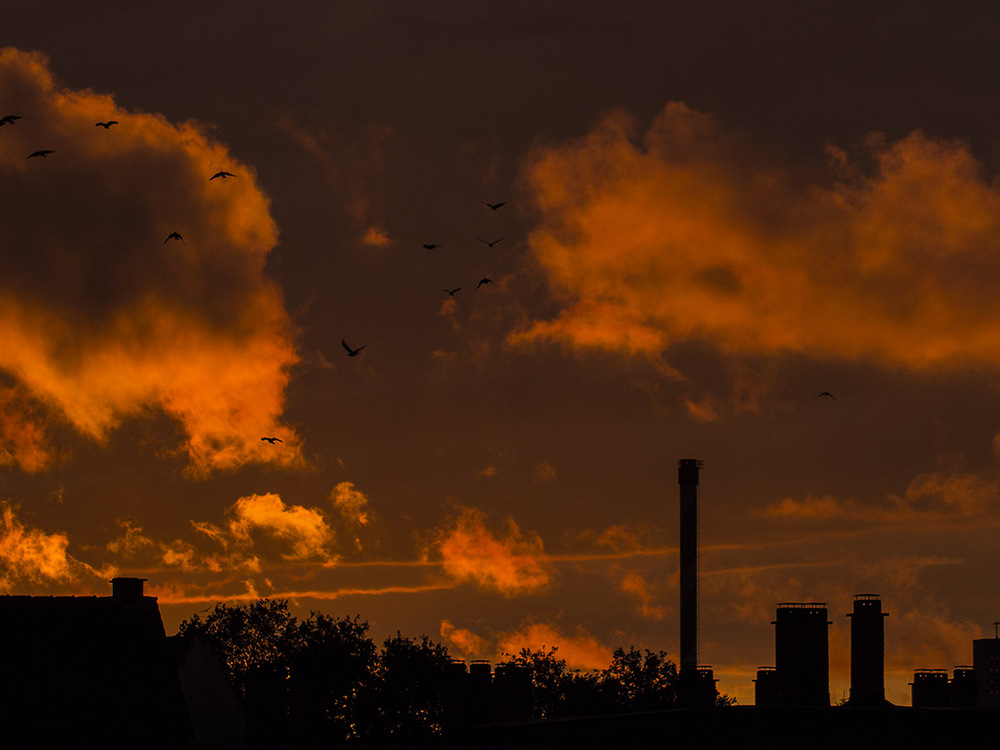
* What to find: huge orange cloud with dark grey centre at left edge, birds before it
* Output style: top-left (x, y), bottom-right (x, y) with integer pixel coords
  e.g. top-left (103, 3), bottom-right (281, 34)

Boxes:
top-left (0, 49), bottom-right (302, 475)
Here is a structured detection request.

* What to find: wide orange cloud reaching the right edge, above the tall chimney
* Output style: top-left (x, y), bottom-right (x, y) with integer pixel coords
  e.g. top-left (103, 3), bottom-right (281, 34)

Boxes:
top-left (509, 103), bottom-right (1000, 370)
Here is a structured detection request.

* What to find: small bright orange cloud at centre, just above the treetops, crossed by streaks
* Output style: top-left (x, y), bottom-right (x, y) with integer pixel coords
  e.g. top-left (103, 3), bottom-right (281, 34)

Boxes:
top-left (425, 508), bottom-right (551, 597)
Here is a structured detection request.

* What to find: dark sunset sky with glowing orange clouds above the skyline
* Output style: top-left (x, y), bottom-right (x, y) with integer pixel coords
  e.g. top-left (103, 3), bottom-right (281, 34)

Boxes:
top-left (0, 0), bottom-right (1000, 704)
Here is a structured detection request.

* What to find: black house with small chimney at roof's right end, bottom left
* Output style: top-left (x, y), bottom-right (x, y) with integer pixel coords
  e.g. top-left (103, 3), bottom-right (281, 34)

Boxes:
top-left (0, 578), bottom-right (191, 747)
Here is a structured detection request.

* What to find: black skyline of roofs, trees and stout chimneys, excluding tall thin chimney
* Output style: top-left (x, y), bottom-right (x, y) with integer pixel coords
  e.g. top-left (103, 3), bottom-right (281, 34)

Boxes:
top-left (0, 580), bottom-right (1000, 748)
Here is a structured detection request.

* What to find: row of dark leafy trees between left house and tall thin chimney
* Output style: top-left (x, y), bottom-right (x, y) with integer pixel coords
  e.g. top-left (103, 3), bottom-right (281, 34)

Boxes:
top-left (179, 599), bottom-right (735, 745)
